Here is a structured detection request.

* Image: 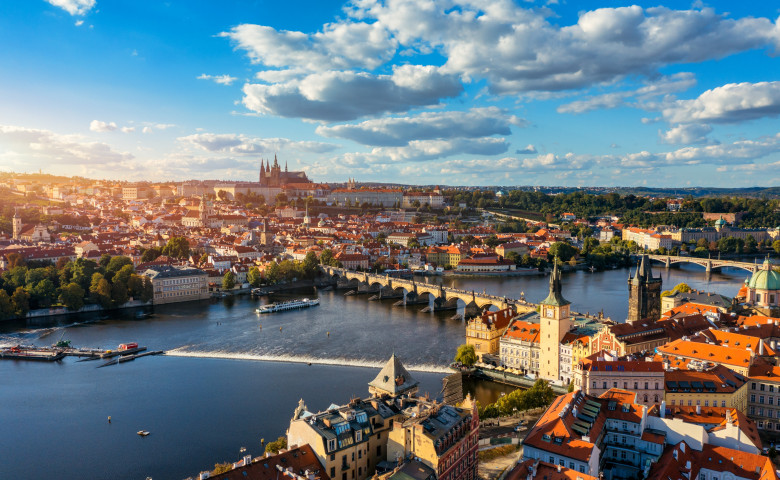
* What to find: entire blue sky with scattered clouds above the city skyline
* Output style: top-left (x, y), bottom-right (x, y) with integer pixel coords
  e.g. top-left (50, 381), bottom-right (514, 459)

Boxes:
top-left (0, 0), bottom-right (780, 187)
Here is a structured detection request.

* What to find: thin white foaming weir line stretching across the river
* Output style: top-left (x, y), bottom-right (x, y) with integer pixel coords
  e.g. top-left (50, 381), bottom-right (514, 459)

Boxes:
top-left (165, 347), bottom-right (450, 373)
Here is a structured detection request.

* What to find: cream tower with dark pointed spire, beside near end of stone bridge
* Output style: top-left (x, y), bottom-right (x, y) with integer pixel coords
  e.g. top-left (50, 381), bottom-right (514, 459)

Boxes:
top-left (539, 258), bottom-right (573, 381)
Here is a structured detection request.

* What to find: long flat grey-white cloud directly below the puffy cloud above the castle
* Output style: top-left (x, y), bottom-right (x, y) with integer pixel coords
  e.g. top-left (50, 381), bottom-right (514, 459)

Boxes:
top-left (316, 107), bottom-right (526, 146)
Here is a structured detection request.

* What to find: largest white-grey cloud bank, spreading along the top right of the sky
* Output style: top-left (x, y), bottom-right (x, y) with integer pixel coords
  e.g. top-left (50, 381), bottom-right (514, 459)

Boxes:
top-left (350, 0), bottom-right (778, 94)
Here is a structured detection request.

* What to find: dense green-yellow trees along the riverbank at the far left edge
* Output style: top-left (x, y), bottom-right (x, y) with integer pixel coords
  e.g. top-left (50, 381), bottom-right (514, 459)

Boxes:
top-left (0, 253), bottom-right (154, 320)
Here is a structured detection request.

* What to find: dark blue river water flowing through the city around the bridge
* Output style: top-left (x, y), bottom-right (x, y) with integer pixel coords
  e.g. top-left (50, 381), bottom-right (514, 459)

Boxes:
top-left (0, 266), bottom-right (746, 479)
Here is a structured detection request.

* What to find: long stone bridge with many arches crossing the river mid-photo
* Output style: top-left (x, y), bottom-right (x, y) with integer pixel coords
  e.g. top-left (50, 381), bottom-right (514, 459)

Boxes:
top-left (320, 265), bottom-right (536, 316)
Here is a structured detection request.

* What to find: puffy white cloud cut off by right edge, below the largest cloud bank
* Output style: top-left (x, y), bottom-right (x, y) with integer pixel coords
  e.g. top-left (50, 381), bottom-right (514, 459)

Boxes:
top-left (663, 82), bottom-right (780, 123)
